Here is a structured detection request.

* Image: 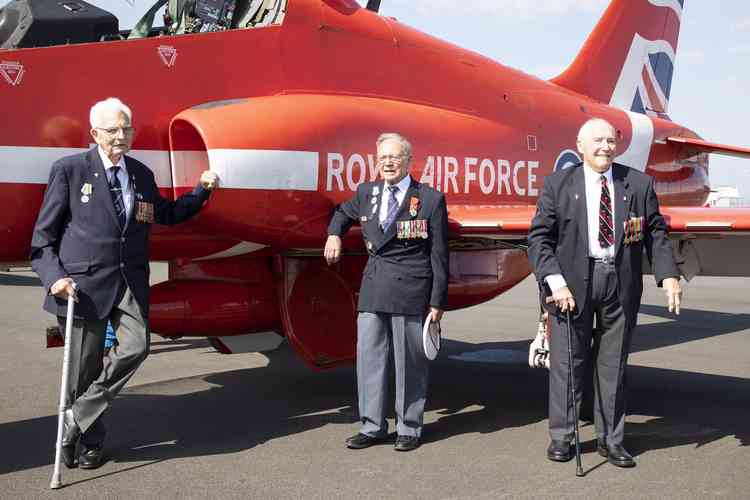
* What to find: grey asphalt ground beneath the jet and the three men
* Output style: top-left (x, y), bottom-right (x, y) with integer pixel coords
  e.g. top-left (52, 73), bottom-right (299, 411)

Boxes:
top-left (0, 266), bottom-right (750, 500)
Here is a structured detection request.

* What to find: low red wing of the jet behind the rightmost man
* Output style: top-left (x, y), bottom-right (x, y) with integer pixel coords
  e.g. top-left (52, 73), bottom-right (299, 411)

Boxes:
top-left (448, 205), bottom-right (750, 280)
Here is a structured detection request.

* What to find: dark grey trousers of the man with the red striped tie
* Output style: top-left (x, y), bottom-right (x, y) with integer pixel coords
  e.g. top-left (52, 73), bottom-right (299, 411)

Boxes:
top-left (549, 262), bottom-right (632, 444)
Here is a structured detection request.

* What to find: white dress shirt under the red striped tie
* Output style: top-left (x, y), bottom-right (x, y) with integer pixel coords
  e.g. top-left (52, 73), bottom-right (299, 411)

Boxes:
top-left (544, 163), bottom-right (617, 292)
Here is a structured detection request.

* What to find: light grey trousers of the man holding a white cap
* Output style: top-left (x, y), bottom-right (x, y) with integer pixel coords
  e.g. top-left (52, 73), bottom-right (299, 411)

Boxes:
top-left (357, 312), bottom-right (429, 437)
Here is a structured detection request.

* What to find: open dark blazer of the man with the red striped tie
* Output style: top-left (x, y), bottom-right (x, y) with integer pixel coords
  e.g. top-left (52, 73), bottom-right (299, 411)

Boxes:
top-left (528, 163), bottom-right (680, 326)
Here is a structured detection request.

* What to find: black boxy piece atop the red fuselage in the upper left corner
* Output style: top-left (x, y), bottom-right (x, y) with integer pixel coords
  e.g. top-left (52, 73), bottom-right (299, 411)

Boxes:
top-left (0, 0), bottom-right (119, 49)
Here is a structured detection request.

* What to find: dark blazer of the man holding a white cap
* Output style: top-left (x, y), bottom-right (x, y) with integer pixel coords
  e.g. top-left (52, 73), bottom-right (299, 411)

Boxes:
top-left (328, 179), bottom-right (448, 315)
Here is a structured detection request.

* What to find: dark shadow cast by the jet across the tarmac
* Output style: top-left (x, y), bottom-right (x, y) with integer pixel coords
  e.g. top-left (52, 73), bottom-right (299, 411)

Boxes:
top-left (0, 324), bottom-right (750, 474)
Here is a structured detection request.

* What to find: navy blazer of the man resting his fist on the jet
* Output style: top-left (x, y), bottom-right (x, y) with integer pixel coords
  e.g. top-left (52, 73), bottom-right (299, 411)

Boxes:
top-left (31, 147), bottom-right (209, 319)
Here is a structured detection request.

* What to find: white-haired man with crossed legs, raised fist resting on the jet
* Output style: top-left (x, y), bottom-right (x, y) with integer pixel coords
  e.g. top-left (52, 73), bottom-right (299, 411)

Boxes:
top-left (31, 98), bottom-right (218, 469)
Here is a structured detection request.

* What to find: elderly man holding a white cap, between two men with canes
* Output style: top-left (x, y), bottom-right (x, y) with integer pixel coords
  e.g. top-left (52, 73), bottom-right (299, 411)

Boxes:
top-left (324, 133), bottom-right (448, 451)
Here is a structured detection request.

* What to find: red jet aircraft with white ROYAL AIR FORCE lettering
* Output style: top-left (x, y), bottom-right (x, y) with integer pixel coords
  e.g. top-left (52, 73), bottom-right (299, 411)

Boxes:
top-left (0, 0), bottom-right (750, 369)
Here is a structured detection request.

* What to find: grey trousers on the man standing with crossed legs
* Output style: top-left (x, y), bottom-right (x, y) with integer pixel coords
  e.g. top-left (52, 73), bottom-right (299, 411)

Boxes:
top-left (57, 288), bottom-right (151, 445)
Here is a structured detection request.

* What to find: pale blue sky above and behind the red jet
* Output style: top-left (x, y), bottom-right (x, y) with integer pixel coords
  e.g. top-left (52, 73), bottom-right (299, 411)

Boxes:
top-left (0, 0), bottom-right (750, 197)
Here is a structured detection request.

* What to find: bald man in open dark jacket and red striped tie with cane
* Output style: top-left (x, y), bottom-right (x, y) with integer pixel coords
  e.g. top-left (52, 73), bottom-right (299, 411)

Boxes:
top-left (529, 119), bottom-right (681, 467)
